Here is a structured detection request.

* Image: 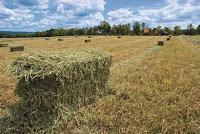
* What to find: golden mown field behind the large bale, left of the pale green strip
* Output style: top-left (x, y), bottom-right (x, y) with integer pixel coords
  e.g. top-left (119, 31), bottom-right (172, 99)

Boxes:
top-left (0, 36), bottom-right (166, 113)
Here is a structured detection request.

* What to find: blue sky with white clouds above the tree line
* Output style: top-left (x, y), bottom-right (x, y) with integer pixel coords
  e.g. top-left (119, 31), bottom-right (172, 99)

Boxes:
top-left (0, 0), bottom-right (200, 32)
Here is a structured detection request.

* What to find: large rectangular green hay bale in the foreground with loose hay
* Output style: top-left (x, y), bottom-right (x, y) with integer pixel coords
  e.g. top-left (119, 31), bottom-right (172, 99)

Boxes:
top-left (0, 50), bottom-right (112, 133)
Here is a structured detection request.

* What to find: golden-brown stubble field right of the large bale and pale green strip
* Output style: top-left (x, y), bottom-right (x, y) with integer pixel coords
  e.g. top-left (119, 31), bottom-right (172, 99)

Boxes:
top-left (61, 37), bottom-right (200, 134)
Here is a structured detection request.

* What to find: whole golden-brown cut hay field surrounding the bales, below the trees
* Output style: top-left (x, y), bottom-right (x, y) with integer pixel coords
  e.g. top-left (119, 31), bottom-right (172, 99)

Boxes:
top-left (0, 36), bottom-right (200, 134)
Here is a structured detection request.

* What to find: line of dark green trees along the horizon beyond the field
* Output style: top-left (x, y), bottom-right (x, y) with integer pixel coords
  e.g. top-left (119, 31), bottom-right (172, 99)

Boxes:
top-left (0, 21), bottom-right (200, 38)
